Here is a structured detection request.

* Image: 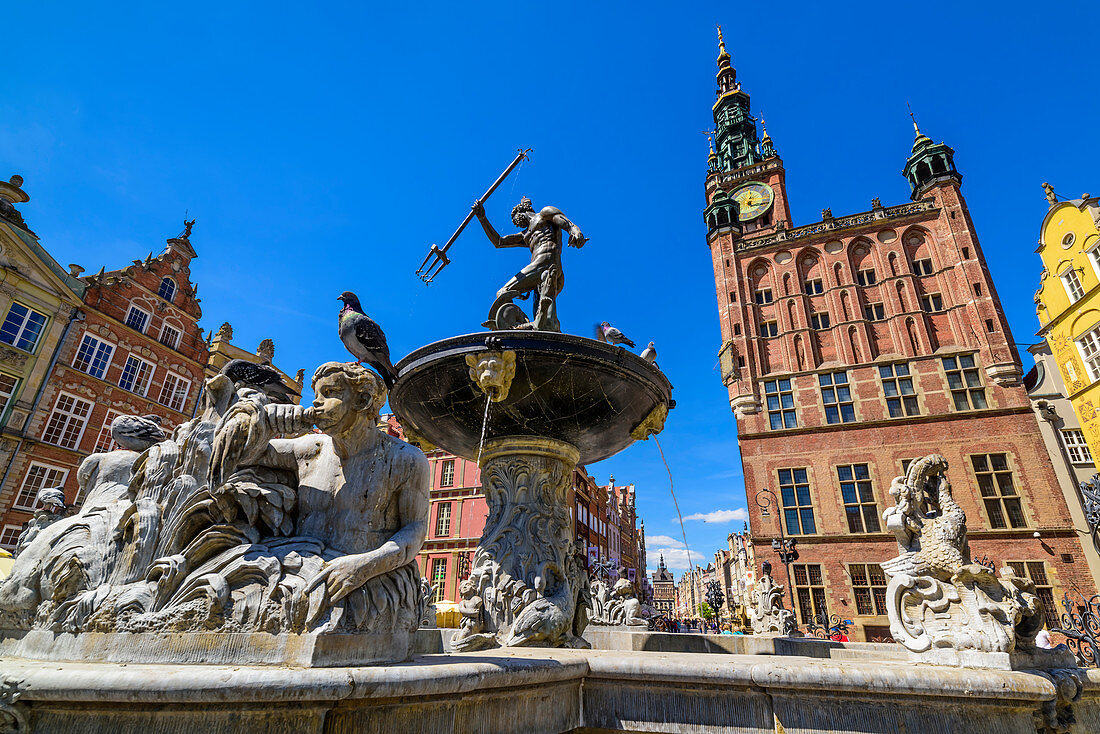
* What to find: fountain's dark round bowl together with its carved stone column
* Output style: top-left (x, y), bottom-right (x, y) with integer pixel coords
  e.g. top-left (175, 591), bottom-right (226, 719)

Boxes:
top-left (389, 330), bottom-right (674, 651)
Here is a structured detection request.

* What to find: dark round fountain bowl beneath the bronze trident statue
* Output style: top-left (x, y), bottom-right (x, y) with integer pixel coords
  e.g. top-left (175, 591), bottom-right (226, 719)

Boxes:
top-left (389, 330), bottom-right (675, 463)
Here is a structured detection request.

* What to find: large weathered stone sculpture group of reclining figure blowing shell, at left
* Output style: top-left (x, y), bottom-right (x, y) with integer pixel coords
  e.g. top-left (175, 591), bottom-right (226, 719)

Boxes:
top-left (0, 362), bottom-right (429, 635)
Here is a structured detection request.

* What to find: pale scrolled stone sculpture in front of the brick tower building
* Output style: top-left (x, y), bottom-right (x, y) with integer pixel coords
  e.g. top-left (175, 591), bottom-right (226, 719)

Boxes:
top-left (882, 454), bottom-right (1043, 654)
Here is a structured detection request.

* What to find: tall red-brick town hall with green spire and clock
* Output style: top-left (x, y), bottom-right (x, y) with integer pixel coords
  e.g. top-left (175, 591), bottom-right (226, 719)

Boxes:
top-left (704, 35), bottom-right (1095, 639)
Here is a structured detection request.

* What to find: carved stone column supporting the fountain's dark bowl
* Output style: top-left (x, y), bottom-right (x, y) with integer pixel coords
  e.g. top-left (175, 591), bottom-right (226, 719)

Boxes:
top-left (451, 436), bottom-right (587, 650)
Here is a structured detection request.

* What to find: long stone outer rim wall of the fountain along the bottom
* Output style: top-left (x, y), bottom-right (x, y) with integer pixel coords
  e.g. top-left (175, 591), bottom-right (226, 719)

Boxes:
top-left (0, 648), bottom-right (1100, 734)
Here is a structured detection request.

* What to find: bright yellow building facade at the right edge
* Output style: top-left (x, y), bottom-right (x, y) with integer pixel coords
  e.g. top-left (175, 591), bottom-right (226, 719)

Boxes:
top-left (1035, 189), bottom-right (1100, 464)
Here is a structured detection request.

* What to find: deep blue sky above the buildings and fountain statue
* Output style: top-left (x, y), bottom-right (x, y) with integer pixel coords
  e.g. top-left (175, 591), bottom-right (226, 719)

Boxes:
top-left (0, 2), bottom-right (1100, 581)
